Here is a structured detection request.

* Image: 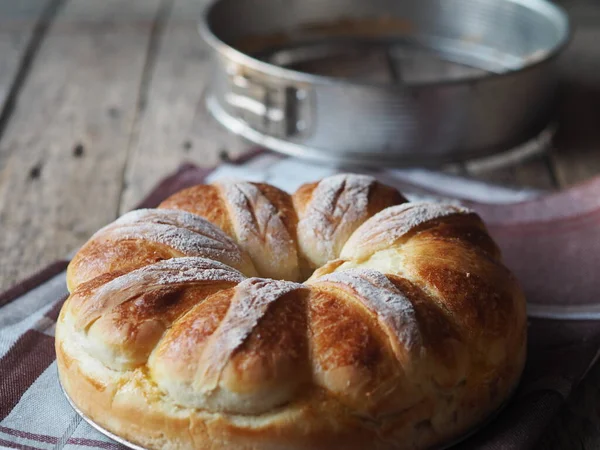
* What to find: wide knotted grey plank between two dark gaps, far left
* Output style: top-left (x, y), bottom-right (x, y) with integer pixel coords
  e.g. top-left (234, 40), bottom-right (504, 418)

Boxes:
top-left (0, 0), bottom-right (159, 289)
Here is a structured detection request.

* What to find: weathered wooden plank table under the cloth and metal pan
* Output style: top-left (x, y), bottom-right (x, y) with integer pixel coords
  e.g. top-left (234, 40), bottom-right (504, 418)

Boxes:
top-left (0, 0), bottom-right (600, 449)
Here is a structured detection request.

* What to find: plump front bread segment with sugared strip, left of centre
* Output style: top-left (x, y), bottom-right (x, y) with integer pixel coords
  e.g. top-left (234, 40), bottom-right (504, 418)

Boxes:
top-left (149, 278), bottom-right (308, 414)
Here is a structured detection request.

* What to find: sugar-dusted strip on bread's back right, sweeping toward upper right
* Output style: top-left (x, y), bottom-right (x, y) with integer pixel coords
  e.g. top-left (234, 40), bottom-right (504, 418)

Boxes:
top-left (341, 202), bottom-right (472, 258)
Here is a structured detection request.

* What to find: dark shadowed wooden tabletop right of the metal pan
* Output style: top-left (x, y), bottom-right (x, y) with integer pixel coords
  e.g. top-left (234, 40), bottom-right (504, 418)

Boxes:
top-left (468, 0), bottom-right (600, 189)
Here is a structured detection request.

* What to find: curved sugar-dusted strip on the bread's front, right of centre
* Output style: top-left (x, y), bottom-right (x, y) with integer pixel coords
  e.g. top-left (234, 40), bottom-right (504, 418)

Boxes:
top-left (314, 269), bottom-right (422, 358)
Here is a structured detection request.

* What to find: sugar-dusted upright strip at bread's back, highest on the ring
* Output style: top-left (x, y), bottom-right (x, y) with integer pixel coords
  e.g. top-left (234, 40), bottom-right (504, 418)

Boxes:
top-left (298, 174), bottom-right (375, 266)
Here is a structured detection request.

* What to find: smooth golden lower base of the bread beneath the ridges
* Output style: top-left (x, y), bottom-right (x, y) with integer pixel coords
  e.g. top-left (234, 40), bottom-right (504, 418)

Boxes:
top-left (56, 314), bottom-right (524, 450)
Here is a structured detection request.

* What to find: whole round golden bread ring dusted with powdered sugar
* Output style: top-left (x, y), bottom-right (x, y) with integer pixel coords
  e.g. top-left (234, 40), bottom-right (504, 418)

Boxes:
top-left (56, 175), bottom-right (526, 449)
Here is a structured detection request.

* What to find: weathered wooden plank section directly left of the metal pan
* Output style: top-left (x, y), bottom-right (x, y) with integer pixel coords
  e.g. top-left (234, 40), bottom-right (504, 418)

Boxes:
top-left (121, 0), bottom-right (245, 212)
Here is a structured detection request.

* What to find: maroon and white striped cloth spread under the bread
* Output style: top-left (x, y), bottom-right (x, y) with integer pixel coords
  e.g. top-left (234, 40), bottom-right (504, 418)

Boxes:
top-left (0, 152), bottom-right (600, 450)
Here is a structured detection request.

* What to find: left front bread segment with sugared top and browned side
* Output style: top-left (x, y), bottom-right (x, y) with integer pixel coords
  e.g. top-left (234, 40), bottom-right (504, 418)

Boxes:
top-left (69, 257), bottom-right (244, 370)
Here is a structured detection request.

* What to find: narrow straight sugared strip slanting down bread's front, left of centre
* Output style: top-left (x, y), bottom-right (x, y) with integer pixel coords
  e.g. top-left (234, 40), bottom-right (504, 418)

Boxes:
top-left (195, 278), bottom-right (303, 391)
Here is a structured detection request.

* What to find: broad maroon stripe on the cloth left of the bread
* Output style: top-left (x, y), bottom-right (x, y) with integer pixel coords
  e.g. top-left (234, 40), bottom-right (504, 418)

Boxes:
top-left (0, 330), bottom-right (55, 420)
